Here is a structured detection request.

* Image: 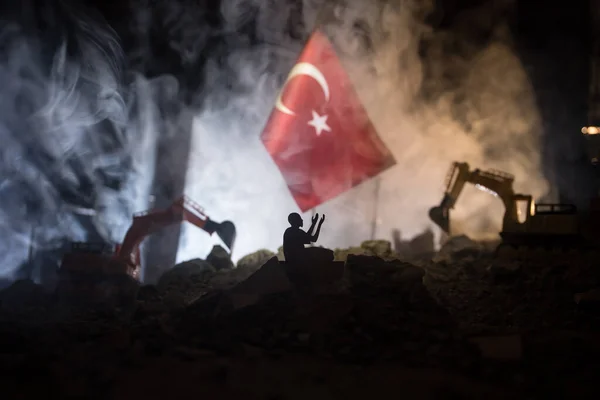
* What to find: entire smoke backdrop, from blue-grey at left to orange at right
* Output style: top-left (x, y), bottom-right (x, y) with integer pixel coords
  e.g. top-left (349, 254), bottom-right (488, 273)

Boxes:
top-left (0, 0), bottom-right (547, 284)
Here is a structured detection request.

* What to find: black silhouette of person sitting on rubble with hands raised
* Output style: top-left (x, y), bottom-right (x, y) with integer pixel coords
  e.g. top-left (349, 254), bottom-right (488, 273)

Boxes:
top-left (283, 213), bottom-right (334, 263)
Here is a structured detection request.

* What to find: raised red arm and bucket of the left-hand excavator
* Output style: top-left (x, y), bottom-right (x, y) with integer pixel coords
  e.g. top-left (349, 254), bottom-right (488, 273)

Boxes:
top-left (115, 196), bottom-right (236, 265)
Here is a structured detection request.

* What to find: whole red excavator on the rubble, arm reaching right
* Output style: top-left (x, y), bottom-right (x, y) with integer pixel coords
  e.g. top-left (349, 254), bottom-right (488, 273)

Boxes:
top-left (57, 196), bottom-right (236, 303)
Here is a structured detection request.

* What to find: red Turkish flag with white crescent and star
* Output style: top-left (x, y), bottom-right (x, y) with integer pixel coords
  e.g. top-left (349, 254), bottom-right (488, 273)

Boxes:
top-left (261, 30), bottom-right (395, 212)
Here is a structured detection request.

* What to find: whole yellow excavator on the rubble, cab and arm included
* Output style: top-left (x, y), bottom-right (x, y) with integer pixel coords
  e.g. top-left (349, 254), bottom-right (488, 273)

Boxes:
top-left (429, 162), bottom-right (600, 247)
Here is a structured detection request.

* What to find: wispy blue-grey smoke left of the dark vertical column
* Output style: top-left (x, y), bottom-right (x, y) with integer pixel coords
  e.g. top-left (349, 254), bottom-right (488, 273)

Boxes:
top-left (0, 2), bottom-right (162, 280)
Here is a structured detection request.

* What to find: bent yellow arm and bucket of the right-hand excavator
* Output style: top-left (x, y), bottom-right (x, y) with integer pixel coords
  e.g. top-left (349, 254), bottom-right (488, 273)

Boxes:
top-left (429, 162), bottom-right (518, 233)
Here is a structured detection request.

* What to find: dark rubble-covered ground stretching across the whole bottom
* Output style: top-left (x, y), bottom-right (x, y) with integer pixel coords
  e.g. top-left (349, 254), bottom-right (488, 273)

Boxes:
top-left (0, 237), bottom-right (600, 399)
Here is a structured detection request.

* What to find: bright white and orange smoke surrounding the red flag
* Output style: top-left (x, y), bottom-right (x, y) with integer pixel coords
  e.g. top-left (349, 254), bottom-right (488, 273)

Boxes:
top-left (179, 1), bottom-right (548, 259)
